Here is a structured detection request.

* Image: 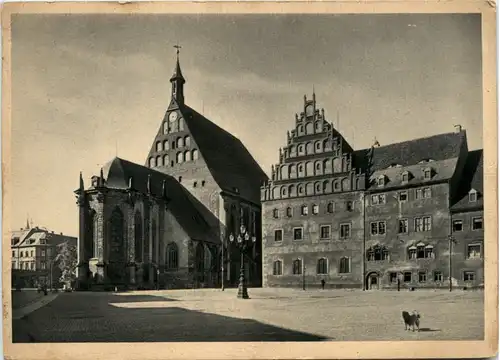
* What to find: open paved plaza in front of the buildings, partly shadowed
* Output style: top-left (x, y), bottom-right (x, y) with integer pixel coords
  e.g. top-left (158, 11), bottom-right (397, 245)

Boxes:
top-left (13, 289), bottom-right (484, 342)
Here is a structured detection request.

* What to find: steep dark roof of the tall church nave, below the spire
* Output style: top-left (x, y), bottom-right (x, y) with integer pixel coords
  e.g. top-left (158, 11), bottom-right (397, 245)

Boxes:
top-left (181, 105), bottom-right (268, 203)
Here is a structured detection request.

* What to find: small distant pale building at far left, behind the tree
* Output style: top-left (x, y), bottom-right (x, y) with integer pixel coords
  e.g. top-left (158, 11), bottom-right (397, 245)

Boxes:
top-left (11, 223), bottom-right (77, 287)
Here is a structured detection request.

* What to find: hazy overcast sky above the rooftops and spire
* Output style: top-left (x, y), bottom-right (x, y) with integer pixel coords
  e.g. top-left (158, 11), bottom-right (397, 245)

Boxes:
top-left (11, 15), bottom-right (482, 235)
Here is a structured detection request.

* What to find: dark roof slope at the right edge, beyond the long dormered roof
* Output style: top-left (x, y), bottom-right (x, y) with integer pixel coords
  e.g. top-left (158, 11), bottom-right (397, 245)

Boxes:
top-left (452, 149), bottom-right (484, 210)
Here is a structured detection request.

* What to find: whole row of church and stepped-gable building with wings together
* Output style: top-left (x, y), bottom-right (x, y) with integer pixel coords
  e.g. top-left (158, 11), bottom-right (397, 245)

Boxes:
top-left (68, 54), bottom-right (484, 289)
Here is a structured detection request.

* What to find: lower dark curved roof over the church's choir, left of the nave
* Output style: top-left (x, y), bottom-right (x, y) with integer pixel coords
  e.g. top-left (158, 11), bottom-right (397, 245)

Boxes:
top-left (103, 157), bottom-right (217, 242)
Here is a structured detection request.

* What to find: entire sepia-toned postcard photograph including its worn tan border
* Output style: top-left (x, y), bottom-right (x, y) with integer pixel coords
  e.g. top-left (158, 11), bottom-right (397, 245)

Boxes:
top-left (3, 5), bottom-right (498, 358)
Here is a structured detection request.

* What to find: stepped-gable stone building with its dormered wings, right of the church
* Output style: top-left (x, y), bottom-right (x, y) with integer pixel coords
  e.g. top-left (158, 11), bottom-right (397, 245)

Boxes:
top-left (261, 94), bottom-right (483, 289)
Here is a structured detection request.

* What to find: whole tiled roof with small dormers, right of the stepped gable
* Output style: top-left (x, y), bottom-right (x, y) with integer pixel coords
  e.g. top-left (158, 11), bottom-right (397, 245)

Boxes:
top-left (353, 131), bottom-right (466, 188)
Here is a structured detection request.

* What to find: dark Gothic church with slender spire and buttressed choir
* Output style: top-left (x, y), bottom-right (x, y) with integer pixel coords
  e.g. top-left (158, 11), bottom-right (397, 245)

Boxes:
top-left (76, 52), bottom-right (267, 288)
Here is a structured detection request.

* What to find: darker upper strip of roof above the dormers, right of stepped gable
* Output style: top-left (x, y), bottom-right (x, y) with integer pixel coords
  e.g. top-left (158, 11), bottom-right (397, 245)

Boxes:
top-left (354, 131), bottom-right (465, 171)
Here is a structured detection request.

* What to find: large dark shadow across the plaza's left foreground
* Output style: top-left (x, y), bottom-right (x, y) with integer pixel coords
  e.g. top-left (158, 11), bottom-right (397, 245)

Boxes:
top-left (12, 293), bottom-right (333, 343)
